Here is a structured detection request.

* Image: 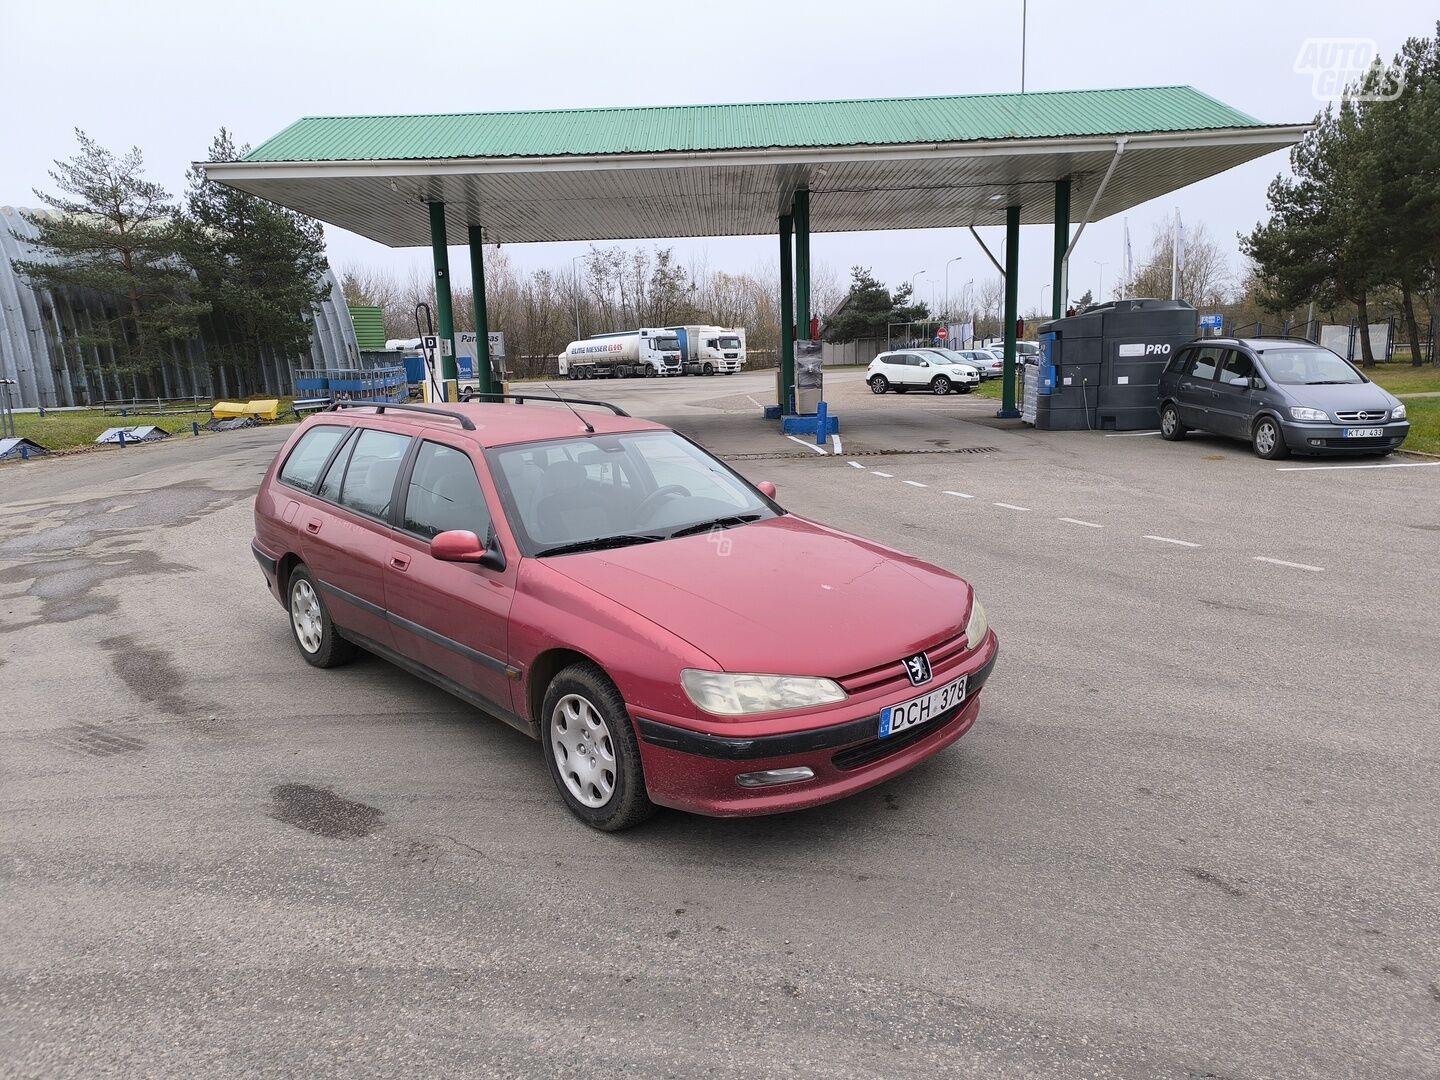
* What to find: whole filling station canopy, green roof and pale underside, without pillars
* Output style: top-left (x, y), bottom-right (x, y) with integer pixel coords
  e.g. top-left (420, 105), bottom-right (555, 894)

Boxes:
top-left (204, 86), bottom-right (1306, 248)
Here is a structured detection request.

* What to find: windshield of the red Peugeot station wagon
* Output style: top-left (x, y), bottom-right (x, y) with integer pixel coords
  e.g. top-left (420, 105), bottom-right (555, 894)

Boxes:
top-left (488, 431), bottom-right (778, 557)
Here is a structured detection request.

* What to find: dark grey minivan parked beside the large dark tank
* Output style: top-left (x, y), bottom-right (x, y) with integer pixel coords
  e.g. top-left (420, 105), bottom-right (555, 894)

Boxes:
top-left (1156, 337), bottom-right (1410, 458)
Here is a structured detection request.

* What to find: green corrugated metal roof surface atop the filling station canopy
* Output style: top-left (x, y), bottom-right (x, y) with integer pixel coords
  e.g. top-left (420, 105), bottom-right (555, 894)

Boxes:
top-left (245, 86), bottom-right (1263, 161)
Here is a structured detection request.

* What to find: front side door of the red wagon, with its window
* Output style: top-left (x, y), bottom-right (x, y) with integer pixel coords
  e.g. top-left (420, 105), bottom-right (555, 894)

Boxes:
top-left (384, 436), bottom-right (520, 714)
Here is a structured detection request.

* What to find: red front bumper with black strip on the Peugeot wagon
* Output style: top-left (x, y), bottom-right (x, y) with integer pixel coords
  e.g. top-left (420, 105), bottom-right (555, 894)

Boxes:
top-left (635, 635), bottom-right (998, 816)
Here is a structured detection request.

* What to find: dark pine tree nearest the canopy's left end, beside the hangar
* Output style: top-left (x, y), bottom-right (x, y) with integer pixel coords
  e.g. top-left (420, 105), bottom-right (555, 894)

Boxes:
top-left (186, 128), bottom-right (330, 394)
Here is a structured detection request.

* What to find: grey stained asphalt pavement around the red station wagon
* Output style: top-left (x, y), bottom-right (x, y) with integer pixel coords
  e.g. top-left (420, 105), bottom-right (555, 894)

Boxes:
top-left (0, 370), bottom-right (1440, 1080)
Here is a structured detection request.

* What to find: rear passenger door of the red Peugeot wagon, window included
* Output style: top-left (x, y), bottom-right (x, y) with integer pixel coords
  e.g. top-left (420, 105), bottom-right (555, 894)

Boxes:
top-left (295, 428), bottom-right (410, 647)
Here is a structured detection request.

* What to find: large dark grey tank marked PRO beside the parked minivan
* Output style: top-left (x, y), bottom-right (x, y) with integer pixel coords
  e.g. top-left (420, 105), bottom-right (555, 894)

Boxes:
top-left (1024, 300), bottom-right (1200, 431)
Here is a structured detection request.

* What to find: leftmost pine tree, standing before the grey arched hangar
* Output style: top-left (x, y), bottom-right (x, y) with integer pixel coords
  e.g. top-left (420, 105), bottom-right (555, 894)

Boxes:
top-left (16, 128), bottom-right (206, 393)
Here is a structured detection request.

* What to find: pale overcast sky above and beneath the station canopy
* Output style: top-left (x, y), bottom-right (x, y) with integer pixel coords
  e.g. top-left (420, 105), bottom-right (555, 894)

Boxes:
top-left (0, 0), bottom-right (1436, 315)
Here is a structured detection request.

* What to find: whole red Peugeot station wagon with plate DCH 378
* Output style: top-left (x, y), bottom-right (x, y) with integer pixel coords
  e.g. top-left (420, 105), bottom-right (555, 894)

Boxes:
top-left (253, 399), bottom-right (996, 829)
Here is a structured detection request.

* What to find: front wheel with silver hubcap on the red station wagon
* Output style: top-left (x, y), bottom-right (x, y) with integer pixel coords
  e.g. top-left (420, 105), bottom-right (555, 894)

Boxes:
top-left (540, 662), bottom-right (655, 832)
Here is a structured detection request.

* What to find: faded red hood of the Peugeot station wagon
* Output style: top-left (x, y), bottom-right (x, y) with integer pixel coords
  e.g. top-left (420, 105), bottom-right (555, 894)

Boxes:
top-left (546, 514), bottom-right (971, 678)
